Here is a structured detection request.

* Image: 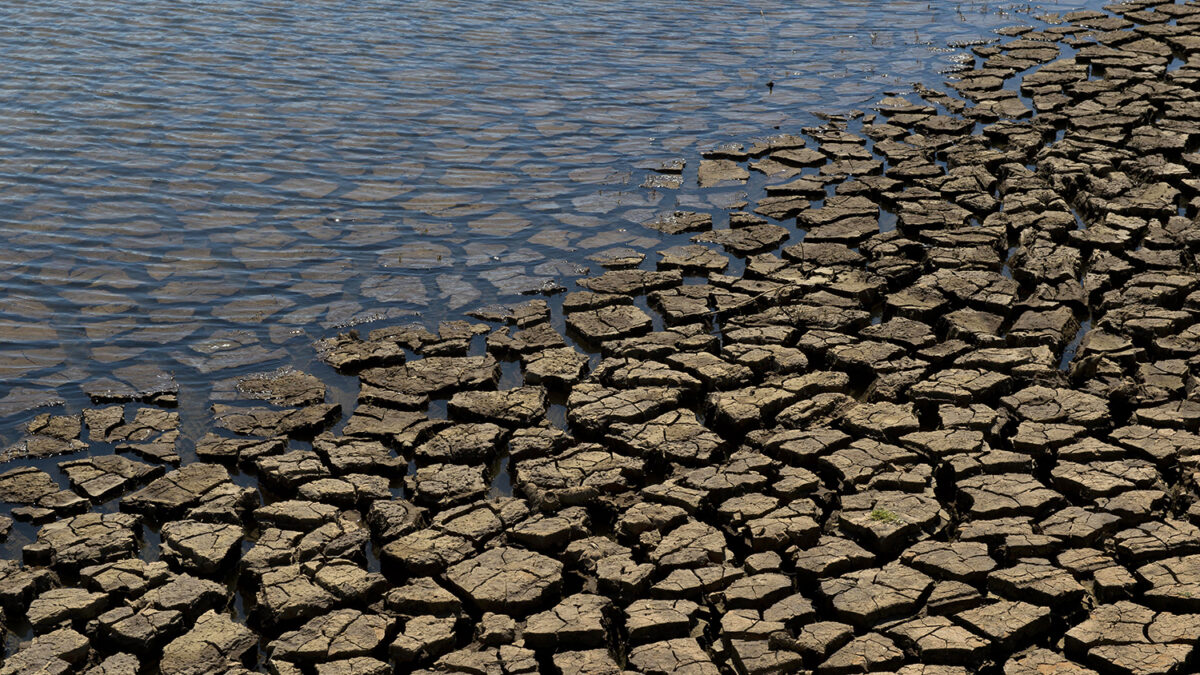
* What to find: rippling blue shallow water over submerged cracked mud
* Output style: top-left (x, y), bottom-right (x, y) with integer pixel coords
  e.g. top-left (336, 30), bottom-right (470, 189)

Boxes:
top-left (0, 0), bottom-right (1097, 441)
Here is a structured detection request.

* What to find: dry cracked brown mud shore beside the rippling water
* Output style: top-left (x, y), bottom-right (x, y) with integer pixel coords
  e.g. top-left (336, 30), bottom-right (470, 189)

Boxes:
top-left (7, 2), bottom-right (1200, 675)
